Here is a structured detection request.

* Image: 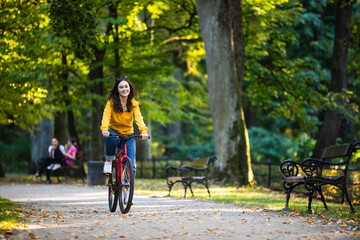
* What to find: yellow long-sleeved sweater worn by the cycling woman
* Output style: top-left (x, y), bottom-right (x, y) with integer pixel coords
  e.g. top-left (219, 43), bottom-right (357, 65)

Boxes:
top-left (100, 99), bottom-right (149, 135)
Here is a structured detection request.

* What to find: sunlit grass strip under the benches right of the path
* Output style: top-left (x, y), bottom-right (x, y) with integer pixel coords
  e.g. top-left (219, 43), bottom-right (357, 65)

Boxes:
top-left (135, 179), bottom-right (360, 223)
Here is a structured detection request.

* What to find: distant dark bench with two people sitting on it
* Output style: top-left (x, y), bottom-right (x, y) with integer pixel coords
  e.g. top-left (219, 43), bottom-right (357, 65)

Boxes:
top-left (40, 151), bottom-right (85, 183)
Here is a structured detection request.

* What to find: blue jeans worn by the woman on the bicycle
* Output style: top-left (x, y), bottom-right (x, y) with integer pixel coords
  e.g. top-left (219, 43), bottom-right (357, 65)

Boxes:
top-left (103, 129), bottom-right (136, 175)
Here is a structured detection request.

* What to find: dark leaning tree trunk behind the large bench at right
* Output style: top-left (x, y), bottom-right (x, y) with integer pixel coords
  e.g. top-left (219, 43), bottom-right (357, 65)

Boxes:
top-left (313, 0), bottom-right (354, 158)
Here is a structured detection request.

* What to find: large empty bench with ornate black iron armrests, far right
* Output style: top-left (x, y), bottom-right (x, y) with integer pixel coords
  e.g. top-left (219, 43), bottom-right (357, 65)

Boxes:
top-left (280, 142), bottom-right (360, 213)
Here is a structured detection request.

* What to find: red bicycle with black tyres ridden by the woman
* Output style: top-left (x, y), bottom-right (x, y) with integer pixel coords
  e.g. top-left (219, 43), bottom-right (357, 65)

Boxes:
top-left (102, 134), bottom-right (150, 214)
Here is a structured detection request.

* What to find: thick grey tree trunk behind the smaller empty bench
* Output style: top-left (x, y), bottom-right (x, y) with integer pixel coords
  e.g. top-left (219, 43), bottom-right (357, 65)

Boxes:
top-left (196, 0), bottom-right (253, 185)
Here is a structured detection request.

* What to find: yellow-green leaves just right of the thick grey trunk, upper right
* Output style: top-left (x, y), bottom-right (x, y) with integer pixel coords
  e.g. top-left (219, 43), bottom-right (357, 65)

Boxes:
top-left (245, 1), bottom-right (324, 131)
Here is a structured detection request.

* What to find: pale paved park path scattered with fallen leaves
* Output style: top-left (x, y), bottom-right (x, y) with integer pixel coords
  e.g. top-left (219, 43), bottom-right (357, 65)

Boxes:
top-left (0, 184), bottom-right (360, 239)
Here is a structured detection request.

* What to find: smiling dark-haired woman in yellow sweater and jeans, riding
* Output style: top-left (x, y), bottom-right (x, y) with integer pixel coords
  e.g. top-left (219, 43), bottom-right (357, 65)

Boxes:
top-left (100, 76), bottom-right (148, 175)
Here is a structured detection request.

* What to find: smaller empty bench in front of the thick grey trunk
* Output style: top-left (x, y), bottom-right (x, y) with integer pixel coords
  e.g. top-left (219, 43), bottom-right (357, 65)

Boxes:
top-left (166, 156), bottom-right (216, 198)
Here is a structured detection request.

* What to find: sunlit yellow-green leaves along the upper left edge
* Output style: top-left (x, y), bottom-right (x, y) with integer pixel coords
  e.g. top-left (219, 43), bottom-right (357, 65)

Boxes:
top-left (0, 1), bottom-right (50, 129)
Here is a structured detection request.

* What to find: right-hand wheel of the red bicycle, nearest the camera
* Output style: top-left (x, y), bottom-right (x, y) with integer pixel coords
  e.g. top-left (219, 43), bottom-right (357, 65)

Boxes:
top-left (119, 158), bottom-right (135, 214)
